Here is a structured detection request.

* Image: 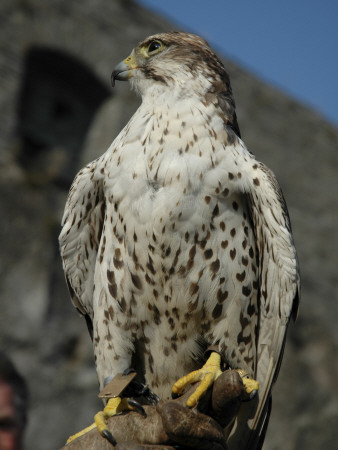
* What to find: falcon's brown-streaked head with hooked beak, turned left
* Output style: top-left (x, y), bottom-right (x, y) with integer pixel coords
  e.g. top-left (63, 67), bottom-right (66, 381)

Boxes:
top-left (112, 31), bottom-right (240, 136)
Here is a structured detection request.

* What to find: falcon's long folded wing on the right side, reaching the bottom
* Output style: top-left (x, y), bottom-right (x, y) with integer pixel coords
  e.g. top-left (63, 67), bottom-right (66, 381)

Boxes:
top-left (229, 159), bottom-right (300, 450)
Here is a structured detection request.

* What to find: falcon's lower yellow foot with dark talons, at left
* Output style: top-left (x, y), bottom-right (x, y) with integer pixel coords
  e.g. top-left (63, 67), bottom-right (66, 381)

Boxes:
top-left (67, 397), bottom-right (145, 445)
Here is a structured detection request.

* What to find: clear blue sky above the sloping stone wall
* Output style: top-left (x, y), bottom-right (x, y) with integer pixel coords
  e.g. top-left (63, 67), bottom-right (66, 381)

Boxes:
top-left (138, 0), bottom-right (338, 125)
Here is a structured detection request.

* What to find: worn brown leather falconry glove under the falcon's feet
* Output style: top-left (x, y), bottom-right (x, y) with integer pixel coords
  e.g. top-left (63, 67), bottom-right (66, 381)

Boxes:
top-left (61, 370), bottom-right (246, 450)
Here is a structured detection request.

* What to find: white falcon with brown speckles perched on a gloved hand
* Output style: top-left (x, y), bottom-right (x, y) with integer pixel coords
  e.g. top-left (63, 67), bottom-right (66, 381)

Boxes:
top-left (59, 32), bottom-right (299, 449)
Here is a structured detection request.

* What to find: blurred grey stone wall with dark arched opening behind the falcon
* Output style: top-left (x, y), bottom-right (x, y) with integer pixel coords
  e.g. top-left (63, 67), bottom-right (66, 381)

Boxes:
top-left (0, 0), bottom-right (338, 450)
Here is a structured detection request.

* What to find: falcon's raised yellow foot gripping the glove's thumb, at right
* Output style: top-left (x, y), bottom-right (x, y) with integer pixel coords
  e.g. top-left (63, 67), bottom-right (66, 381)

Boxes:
top-left (172, 352), bottom-right (222, 408)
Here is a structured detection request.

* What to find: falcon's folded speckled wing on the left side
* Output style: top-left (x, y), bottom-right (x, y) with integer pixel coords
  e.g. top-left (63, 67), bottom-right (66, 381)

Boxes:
top-left (59, 160), bottom-right (105, 315)
